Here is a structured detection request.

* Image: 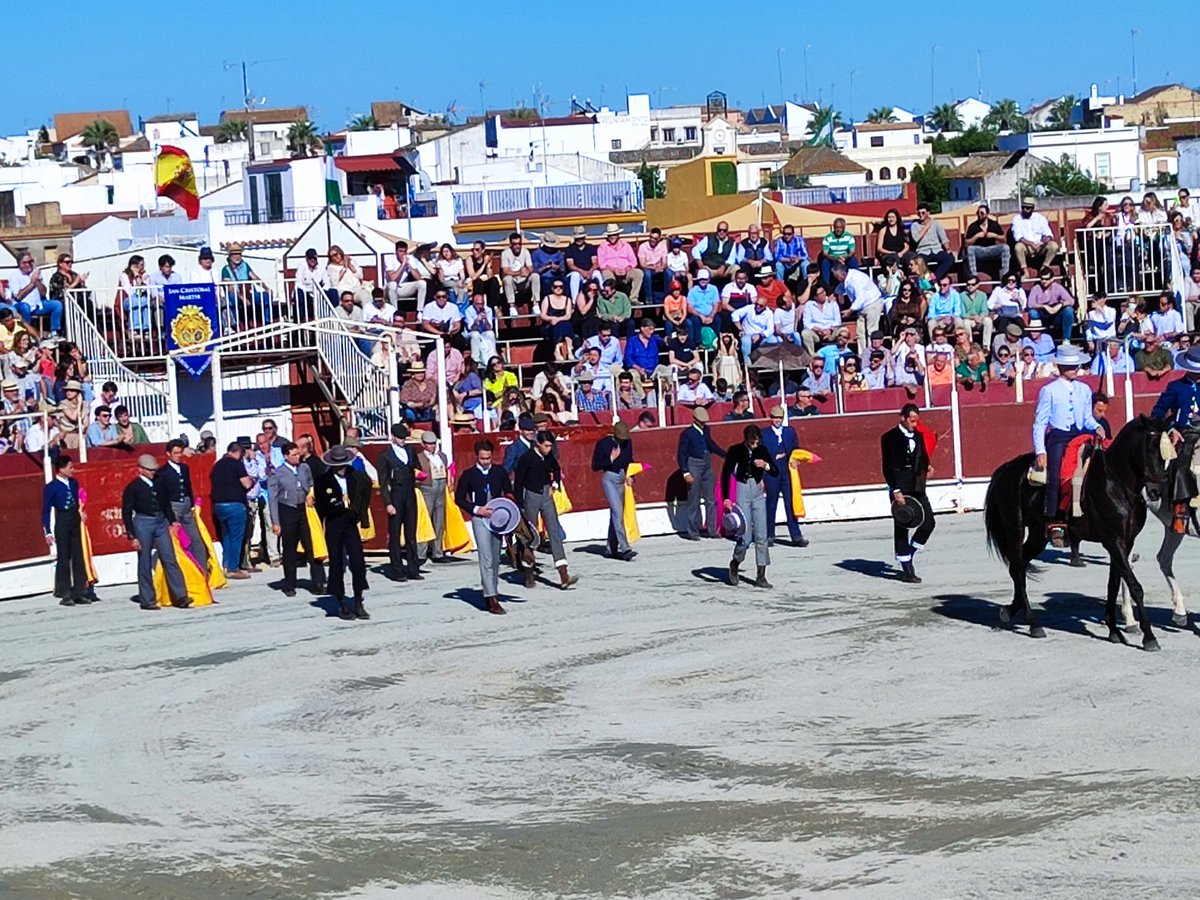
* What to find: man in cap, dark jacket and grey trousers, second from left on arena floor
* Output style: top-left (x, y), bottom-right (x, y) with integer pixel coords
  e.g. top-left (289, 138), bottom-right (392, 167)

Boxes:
top-left (121, 454), bottom-right (189, 611)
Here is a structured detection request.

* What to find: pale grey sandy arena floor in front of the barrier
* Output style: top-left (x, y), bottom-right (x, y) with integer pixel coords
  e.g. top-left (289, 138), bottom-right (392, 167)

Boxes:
top-left (0, 515), bottom-right (1200, 900)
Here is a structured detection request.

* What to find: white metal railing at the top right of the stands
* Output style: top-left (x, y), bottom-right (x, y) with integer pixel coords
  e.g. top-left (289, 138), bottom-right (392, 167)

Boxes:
top-left (1075, 224), bottom-right (1189, 296)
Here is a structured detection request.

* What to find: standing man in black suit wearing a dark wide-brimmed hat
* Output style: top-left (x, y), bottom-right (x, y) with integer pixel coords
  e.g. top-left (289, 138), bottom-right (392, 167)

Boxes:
top-left (313, 444), bottom-right (371, 619)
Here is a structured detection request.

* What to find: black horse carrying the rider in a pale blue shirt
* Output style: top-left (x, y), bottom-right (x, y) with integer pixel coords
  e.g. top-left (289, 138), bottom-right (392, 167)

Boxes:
top-left (984, 415), bottom-right (1166, 650)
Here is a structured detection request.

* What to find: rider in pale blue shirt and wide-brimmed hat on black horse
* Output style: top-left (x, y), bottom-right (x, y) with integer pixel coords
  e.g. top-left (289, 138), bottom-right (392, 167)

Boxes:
top-left (1033, 344), bottom-right (1104, 548)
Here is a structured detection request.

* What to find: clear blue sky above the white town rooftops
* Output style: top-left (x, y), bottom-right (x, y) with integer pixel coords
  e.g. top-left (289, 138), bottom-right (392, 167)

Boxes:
top-left (0, 0), bottom-right (1200, 133)
